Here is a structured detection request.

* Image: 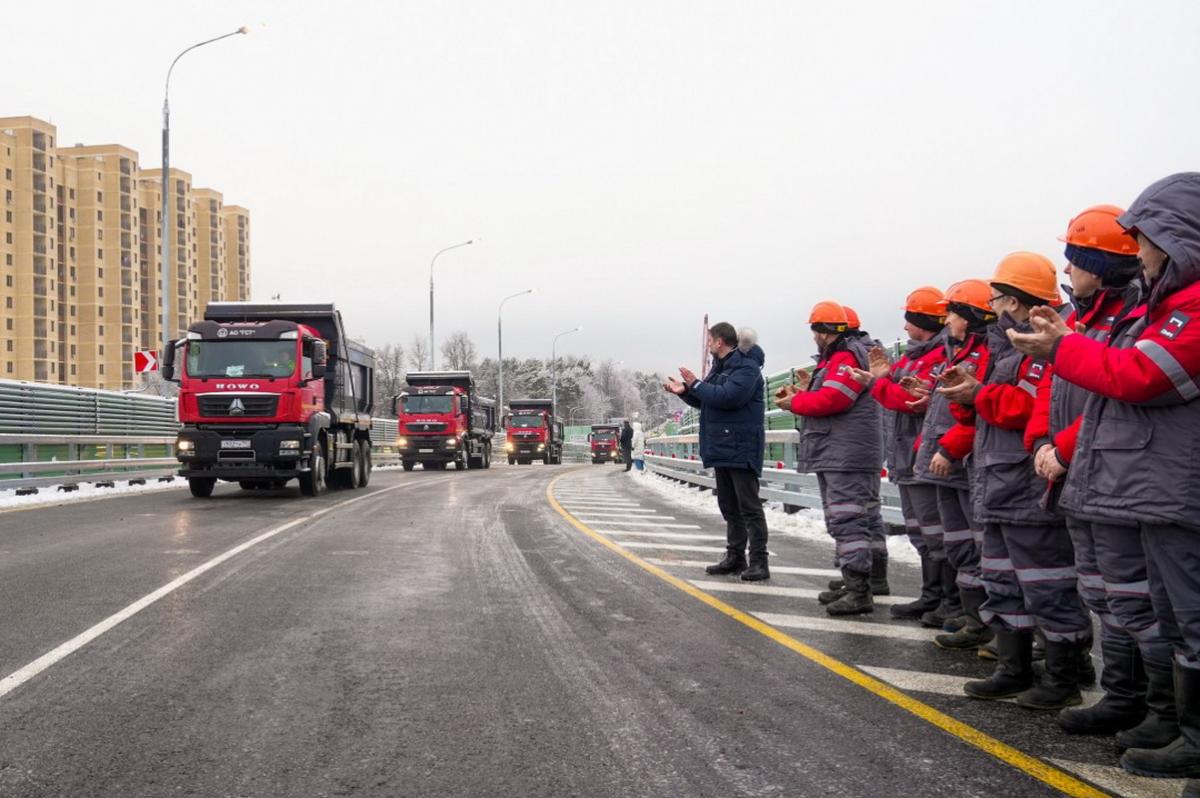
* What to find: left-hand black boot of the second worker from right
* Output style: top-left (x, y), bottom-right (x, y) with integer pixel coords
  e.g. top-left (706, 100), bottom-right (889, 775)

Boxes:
top-left (1058, 640), bottom-right (1146, 734)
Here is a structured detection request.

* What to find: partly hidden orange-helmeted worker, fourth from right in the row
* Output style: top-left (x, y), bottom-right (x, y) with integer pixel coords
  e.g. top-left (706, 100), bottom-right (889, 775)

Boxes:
top-left (913, 280), bottom-right (996, 633)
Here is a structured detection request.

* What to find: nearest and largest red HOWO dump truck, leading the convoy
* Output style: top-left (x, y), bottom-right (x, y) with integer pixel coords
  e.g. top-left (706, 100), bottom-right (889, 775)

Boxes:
top-left (163, 302), bottom-right (374, 498)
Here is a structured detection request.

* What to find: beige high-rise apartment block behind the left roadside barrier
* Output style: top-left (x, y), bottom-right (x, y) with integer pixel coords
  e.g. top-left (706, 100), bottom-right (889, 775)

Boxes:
top-left (0, 116), bottom-right (250, 390)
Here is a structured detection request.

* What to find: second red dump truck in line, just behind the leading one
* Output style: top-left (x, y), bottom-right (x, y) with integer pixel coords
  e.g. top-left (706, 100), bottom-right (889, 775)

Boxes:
top-left (391, 371), bottom-right (496, 472)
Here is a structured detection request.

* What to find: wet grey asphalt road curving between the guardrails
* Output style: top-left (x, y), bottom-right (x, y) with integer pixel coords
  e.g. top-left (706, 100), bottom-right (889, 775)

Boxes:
top-left (0, 464), bottom-right (1177, 798)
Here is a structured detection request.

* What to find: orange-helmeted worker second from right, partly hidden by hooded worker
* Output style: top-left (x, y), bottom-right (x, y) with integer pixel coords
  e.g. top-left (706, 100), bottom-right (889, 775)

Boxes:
top-left (1025, 205), bottom-right (1178, 750)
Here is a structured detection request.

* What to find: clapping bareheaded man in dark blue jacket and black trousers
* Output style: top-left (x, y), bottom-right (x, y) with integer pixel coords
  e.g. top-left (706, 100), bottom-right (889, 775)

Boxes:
top-left (664, 322), bottom-right (770, 582)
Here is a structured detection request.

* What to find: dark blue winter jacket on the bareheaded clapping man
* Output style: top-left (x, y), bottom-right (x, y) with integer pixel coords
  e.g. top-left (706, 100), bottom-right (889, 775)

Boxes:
top-left (682, 346), bottom-right (767, 476)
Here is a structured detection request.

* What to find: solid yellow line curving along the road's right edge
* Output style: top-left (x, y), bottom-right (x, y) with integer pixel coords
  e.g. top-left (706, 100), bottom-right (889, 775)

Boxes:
top-left (546, 474), bottom-right (1109, 798)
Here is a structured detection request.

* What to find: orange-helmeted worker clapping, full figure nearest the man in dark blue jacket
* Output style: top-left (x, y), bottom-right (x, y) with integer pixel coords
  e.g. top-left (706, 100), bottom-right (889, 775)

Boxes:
top-left (775, 301), bottom-right (883, 616)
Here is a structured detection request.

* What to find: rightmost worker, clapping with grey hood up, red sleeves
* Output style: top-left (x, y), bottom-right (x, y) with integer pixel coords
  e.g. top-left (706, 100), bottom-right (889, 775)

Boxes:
top-left (1013, 172), bottom-right (1200, 782)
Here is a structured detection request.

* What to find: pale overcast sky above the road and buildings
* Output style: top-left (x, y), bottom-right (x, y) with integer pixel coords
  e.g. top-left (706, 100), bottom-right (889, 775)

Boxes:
top-left (0, 0), bottom-right (1200, 371)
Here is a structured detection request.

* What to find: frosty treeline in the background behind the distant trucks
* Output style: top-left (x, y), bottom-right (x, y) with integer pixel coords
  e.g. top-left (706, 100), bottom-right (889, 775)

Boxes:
top-left (376, 331), bottom-right (673, 426)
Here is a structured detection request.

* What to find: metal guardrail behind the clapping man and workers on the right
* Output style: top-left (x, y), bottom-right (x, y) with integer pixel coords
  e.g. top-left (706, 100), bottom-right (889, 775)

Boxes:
top-left (646, 430), bottom-right (904, 527)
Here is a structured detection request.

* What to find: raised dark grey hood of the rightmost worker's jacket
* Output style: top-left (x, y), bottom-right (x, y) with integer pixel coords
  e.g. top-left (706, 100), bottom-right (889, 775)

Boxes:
top-left (1117, 172), bottom-right (1200, 308)
